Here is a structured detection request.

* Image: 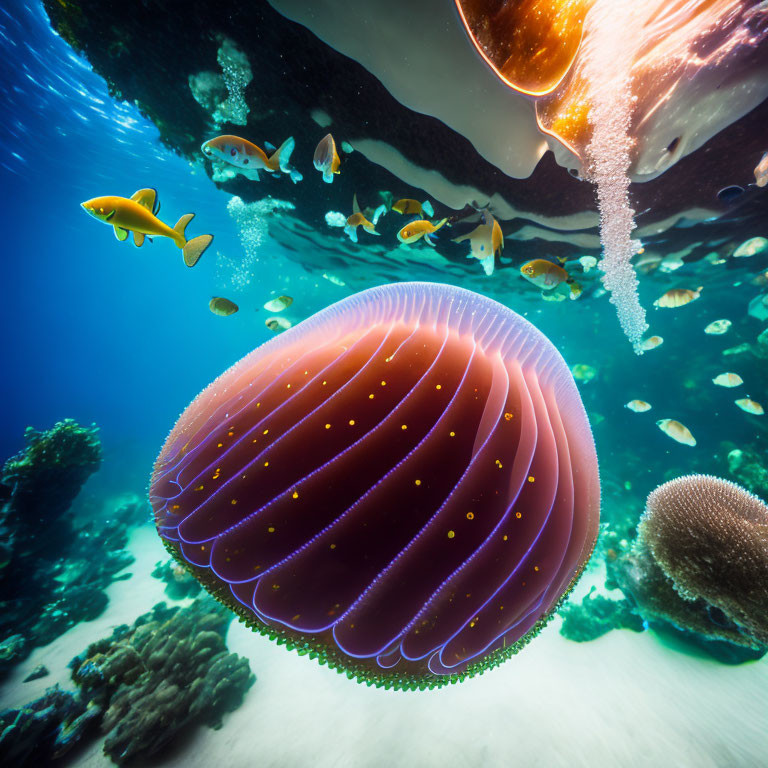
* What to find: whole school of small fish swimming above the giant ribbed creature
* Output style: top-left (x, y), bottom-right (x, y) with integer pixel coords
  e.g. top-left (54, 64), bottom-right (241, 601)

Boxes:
top-left (81, 133), bottom-right (768, 460)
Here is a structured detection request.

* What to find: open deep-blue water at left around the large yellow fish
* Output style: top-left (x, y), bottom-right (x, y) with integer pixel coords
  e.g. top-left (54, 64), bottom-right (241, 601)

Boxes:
top-left (0, 1), bottom-right (308, 487)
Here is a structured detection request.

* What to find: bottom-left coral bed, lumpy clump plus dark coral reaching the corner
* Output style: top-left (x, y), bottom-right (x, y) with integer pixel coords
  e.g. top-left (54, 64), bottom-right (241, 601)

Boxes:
top-left (0, 597), bottom-right (255, 768)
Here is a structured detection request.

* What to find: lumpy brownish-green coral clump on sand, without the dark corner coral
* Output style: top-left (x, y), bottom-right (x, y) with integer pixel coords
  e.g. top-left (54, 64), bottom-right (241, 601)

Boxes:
top-left (71, 596), bottom-right (255, 765)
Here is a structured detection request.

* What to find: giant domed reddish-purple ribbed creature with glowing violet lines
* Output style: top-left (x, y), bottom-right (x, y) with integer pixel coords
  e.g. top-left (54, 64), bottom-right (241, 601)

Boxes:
top-left (151, 283), bottom-right (600, 688)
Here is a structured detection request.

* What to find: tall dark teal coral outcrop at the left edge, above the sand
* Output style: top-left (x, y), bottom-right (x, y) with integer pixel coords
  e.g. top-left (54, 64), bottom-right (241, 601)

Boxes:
top-left (0, 420), bottom-right (147, 672)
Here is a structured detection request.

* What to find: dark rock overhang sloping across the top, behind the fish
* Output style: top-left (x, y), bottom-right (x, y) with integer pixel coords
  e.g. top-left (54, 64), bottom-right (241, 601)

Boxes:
top-left (44, 0), bottom-right (768, 261)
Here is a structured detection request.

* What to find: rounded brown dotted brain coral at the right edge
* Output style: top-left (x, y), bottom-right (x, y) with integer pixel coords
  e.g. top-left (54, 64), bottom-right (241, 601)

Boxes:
top-left (640, 475), bottom-right (768, 643)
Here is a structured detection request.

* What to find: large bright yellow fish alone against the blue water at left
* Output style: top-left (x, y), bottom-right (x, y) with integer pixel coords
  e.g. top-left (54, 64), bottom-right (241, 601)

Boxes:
top-left (80, 189), bottom-right (213, 267)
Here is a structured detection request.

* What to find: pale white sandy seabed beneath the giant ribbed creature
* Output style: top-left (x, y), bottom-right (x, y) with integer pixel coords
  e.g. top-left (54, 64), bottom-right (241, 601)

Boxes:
top-left (0, 527), bottom-right (768, 768)
